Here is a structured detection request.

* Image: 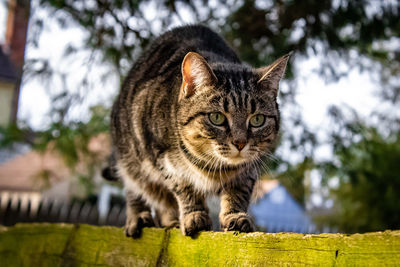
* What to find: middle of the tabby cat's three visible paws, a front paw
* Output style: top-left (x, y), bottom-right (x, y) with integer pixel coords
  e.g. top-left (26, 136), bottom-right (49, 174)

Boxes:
top-left (181, 211), bottom-right (212, 236)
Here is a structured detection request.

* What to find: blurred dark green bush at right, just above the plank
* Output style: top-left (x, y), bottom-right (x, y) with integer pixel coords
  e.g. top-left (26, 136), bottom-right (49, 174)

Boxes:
top-left (320, 123), bottom-right (400, 233)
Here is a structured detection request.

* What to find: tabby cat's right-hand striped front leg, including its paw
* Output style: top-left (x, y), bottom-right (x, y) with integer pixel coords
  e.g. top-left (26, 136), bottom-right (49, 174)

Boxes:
top-left (219, 178), bottom-right (255, 233)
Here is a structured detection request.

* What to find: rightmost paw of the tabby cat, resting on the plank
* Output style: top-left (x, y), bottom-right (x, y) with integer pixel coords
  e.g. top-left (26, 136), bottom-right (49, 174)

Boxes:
top-left (221, 212), bottom-right (255, 233)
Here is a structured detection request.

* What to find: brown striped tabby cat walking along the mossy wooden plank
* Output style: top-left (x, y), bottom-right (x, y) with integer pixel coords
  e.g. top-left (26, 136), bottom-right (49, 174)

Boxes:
top-left (109, 26), bottom-right (289, 237)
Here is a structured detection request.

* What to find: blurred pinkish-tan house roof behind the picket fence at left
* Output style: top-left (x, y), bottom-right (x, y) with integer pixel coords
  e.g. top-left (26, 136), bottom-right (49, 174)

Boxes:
top-left (0, 133), bottom-right (111, 192)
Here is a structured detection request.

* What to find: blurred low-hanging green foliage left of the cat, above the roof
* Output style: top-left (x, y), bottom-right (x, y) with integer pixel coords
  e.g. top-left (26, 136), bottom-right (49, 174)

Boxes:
top-left (0, 105), bottom-right (110, 198)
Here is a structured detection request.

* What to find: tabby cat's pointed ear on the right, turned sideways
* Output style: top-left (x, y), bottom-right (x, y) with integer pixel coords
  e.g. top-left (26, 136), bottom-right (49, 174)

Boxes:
top-left (256, 52), bottom-right (292, 98)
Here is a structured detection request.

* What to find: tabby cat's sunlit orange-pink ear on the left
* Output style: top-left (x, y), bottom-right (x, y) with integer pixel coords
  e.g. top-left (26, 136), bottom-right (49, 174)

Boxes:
top-left (179, 52), bottom-right (217, 99)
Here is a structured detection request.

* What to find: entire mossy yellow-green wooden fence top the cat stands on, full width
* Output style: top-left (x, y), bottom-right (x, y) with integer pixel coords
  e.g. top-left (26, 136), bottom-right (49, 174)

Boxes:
top-left (0, 224), bottom-right (400, 266)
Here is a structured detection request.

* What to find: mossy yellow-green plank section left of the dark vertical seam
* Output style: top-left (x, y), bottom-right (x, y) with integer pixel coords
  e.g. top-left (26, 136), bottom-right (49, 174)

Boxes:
top-left (0, 223), bottom-right (165, 266)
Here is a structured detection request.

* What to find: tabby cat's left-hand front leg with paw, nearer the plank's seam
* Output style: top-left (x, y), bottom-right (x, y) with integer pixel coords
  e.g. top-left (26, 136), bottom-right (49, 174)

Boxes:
top-left (173, 184), bottom-right (212, 236)
